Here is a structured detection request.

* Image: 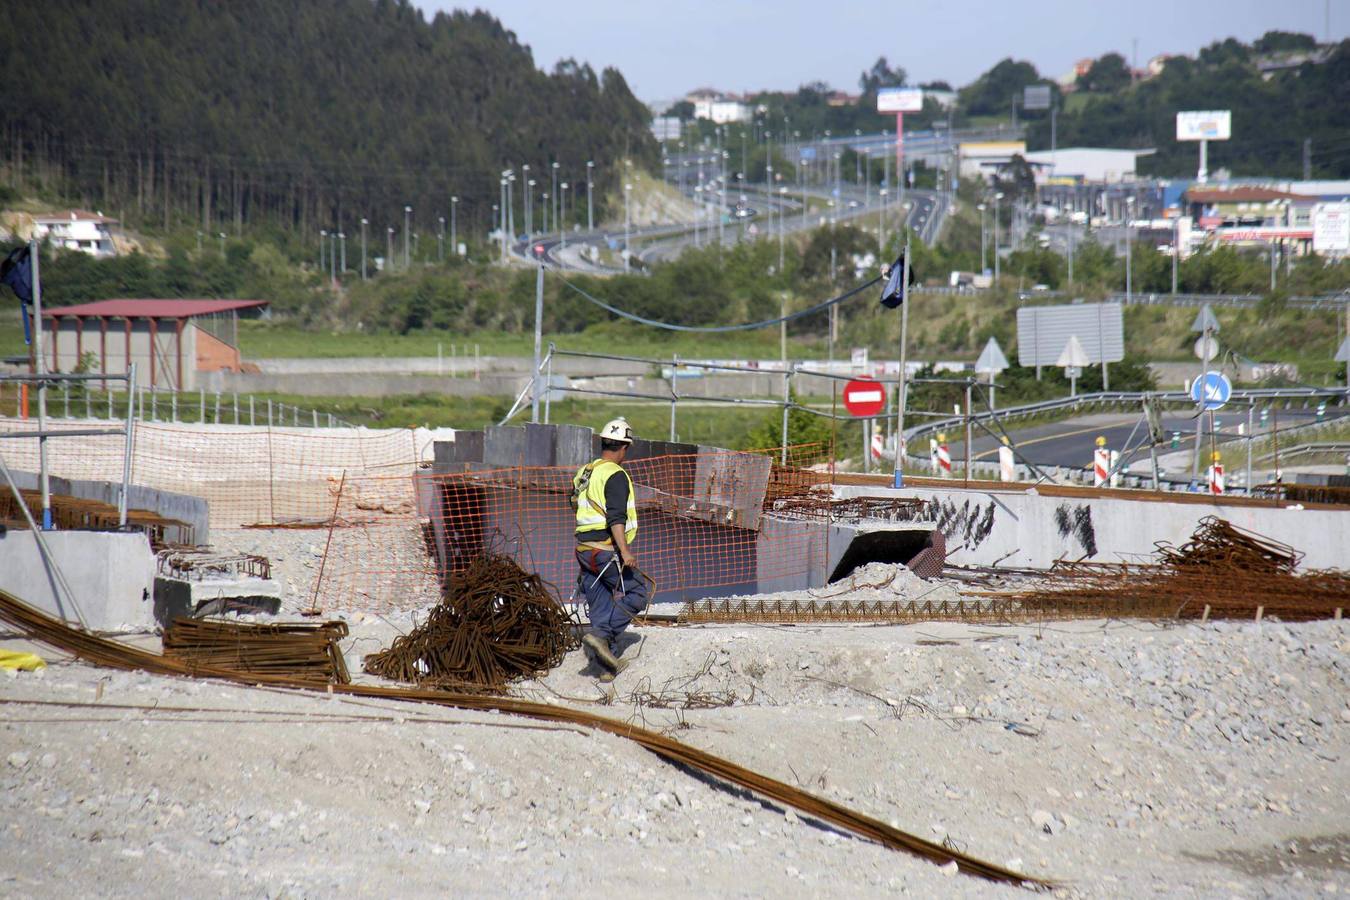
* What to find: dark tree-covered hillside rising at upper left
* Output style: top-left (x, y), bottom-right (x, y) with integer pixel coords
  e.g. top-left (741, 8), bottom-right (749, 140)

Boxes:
top-left (0, 0), bottom-right (655, 240)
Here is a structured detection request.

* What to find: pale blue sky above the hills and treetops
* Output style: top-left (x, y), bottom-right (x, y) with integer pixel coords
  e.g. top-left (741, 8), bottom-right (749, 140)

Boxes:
top-left (413, 0), bottom-right (1350, 103)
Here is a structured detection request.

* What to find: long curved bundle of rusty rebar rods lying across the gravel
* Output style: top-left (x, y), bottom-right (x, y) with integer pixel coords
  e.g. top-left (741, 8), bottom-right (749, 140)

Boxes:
top-left (0, 590), bottom-right (1056, 888)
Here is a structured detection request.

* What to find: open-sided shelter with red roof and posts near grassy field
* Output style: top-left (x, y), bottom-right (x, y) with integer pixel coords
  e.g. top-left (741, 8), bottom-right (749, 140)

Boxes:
top-left (42, 300), bottom-right (267, 391)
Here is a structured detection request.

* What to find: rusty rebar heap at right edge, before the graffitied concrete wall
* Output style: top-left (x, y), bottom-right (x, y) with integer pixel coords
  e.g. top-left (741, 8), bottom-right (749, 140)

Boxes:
top-left (1000, 517), bottom-right (1350, 621)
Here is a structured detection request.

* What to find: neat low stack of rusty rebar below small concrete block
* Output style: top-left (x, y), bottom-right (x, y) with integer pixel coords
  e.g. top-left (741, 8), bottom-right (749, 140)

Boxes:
top-left (163, 618), bottom-right (351, 684)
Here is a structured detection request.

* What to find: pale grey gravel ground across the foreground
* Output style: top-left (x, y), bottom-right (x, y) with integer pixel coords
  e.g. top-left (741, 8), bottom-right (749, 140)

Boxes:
top-left (0, 614), bottom-right (1350, 897)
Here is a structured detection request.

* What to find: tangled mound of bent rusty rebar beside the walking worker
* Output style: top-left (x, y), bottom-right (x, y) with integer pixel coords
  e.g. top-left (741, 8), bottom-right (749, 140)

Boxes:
top-left (365, 556), bottom-right (581, 691)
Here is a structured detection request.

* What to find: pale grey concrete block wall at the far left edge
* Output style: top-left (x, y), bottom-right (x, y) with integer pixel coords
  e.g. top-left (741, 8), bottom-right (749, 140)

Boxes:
top-left (0, 529), bottom-right (155, 631)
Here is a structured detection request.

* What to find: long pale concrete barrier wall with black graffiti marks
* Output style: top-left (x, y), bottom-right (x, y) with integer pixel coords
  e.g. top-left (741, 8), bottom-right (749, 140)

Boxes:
top-left (836, 486), bottom-right (1350, 568)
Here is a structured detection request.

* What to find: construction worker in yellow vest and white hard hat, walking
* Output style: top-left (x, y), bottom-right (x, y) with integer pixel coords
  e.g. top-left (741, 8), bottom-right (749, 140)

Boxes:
top-left (572, 418), bottom-right (648, 681)
